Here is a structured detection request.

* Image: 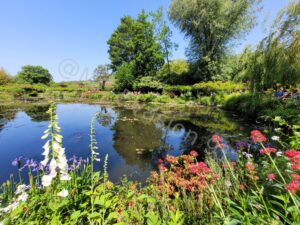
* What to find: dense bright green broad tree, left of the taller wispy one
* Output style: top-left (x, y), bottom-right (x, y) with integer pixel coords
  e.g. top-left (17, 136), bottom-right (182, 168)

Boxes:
top-left (108, 11), bottom-right (164, 78)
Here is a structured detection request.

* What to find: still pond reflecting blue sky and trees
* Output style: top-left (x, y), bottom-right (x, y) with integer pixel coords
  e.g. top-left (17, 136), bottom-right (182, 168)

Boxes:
top-left (0, 103), bottom-right (254, 183)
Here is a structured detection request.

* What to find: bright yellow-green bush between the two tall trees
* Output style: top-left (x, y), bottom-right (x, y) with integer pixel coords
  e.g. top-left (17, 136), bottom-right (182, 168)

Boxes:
top-left (158, 59), bottom-right (189, 85)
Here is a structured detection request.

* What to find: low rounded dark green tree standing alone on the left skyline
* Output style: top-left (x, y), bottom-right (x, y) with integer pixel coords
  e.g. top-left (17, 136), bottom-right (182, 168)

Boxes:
top-left (16, 65), bottom-right (53, 84)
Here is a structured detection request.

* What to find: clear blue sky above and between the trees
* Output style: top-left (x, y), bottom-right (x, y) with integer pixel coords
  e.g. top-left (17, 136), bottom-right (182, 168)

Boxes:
top-left (0, 0), bottom-right (296, 81)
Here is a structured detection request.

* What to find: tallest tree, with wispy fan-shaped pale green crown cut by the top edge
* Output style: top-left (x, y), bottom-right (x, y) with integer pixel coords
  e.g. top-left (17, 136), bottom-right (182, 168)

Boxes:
top-left (169, 0), bottom-right (259, 80)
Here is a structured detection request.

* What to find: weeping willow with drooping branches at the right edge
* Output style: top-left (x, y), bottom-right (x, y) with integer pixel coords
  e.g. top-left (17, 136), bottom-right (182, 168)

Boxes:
top-left (247, 2), bottom-right (300, 91)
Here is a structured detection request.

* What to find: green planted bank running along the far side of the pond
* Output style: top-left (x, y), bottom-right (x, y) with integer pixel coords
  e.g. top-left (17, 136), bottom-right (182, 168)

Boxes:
top-left (0, 82), bottom-right (300, 123)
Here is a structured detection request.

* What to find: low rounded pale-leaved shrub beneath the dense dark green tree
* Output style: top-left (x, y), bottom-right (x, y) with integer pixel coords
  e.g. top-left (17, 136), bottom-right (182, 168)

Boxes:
top-left (134, 77), bottom-right (163, 92)
